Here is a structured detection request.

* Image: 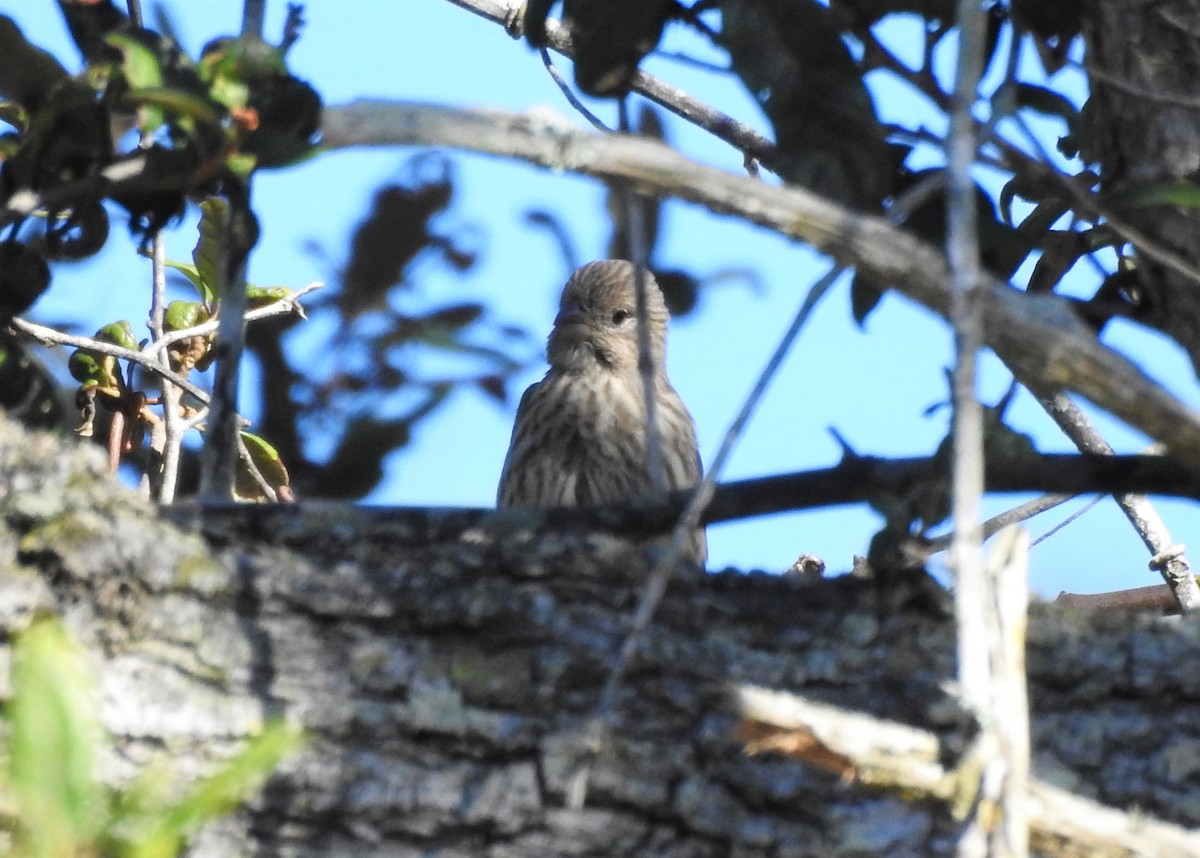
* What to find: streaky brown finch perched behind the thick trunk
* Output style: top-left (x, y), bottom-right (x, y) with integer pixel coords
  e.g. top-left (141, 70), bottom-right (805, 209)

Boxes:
top-left (497, 259), bottom-right (708, 566)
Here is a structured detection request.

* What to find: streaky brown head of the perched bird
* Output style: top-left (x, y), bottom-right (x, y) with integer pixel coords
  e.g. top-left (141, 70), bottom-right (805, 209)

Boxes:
top-left (546, 259), bottom-right (668, 372)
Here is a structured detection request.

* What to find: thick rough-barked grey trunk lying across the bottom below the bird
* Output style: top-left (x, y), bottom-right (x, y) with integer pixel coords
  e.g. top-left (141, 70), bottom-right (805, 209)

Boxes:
top-left (0, 418), bottom-right (1200, 858)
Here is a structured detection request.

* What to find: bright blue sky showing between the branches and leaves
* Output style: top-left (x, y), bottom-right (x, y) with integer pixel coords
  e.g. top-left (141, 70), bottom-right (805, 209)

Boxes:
top-left (11, 0), bottom-right (1200, 595)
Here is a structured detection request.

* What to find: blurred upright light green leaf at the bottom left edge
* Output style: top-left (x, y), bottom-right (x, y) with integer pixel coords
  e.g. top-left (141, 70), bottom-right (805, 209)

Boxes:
top-left (8, 618), bottom-right (102, 856)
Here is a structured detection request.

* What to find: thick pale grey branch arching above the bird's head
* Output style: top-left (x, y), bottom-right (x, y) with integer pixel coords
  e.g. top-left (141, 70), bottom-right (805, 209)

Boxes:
top-left (323, 101), bottom-right (1200, 468)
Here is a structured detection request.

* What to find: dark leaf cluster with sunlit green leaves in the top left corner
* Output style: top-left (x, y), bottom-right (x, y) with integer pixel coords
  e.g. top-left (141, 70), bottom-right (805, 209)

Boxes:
top-left (0, 4), bottom-right (320, 320)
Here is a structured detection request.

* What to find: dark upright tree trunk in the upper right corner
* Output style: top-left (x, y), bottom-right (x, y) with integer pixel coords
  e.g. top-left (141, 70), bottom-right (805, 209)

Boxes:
top-left (1084, 0), bottom-right (1200, 372)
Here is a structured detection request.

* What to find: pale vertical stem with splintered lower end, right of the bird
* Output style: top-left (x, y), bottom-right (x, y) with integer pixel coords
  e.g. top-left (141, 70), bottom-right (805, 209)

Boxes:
top-left (946, 0), bottom-right (1030, 858)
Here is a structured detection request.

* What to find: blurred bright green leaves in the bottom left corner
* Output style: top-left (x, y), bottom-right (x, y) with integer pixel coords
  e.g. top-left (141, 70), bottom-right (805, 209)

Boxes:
top-left (0, 617), bottom-right (304, 858)
